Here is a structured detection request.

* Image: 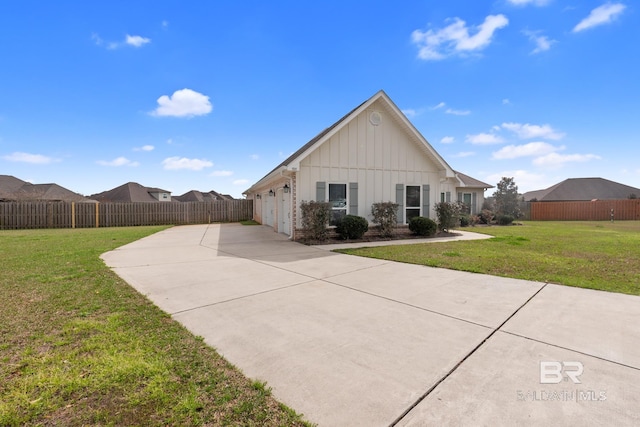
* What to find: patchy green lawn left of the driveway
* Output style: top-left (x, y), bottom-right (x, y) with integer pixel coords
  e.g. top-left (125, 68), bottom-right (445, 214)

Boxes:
top-left (0, 227), bottom-right (307, 426)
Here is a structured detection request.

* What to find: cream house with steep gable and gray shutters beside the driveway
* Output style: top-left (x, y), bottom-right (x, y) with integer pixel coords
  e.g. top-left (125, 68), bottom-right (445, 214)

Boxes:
top-left (244, 91), bottom-right (492, 239)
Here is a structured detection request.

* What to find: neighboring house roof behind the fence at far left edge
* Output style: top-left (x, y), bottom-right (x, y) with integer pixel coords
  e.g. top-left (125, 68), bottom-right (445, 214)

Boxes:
top-left (0, 175), bottom-right (95, 203)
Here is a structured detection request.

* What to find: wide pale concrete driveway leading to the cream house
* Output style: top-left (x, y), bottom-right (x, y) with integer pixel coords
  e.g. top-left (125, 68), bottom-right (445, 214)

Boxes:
top-left (103, 224), bottom-right (640, 426)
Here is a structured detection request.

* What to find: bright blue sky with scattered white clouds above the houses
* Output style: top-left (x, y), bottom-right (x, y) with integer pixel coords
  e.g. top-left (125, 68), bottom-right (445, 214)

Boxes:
top-left (0, 0), bottom-right (640, 197)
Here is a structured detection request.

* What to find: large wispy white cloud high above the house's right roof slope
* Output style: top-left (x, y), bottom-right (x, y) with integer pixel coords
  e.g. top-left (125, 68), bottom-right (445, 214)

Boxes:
top-left (411, 15), bottom-right (509, 61)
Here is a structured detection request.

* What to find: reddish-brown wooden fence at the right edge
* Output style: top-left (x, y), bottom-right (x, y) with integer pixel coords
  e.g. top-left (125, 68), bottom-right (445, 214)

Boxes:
top-left (530, 199), bottom-right (640, 221)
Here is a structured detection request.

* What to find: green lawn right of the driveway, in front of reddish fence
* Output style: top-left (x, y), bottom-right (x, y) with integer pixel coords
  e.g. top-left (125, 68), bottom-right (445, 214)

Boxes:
top-left (338, 221), bottom-right (640, 295)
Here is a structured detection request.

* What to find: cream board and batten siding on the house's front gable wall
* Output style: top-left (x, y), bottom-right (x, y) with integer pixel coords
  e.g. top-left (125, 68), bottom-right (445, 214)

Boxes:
top-left (296, 103), bottom-right (455, 220)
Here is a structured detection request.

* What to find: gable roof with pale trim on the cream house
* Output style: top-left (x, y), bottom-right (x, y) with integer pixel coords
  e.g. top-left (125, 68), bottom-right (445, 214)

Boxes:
top-left (244, 90), bottom-right (455, 194)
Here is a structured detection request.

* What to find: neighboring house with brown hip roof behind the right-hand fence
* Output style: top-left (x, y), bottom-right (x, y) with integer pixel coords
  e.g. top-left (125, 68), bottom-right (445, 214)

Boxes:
top-left (522, 178), bottom-right (640, 202)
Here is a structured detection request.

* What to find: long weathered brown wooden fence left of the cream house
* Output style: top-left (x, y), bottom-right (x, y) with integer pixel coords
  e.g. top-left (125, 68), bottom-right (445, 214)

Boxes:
top-left (0, 200), bottom-right (253, 230)
